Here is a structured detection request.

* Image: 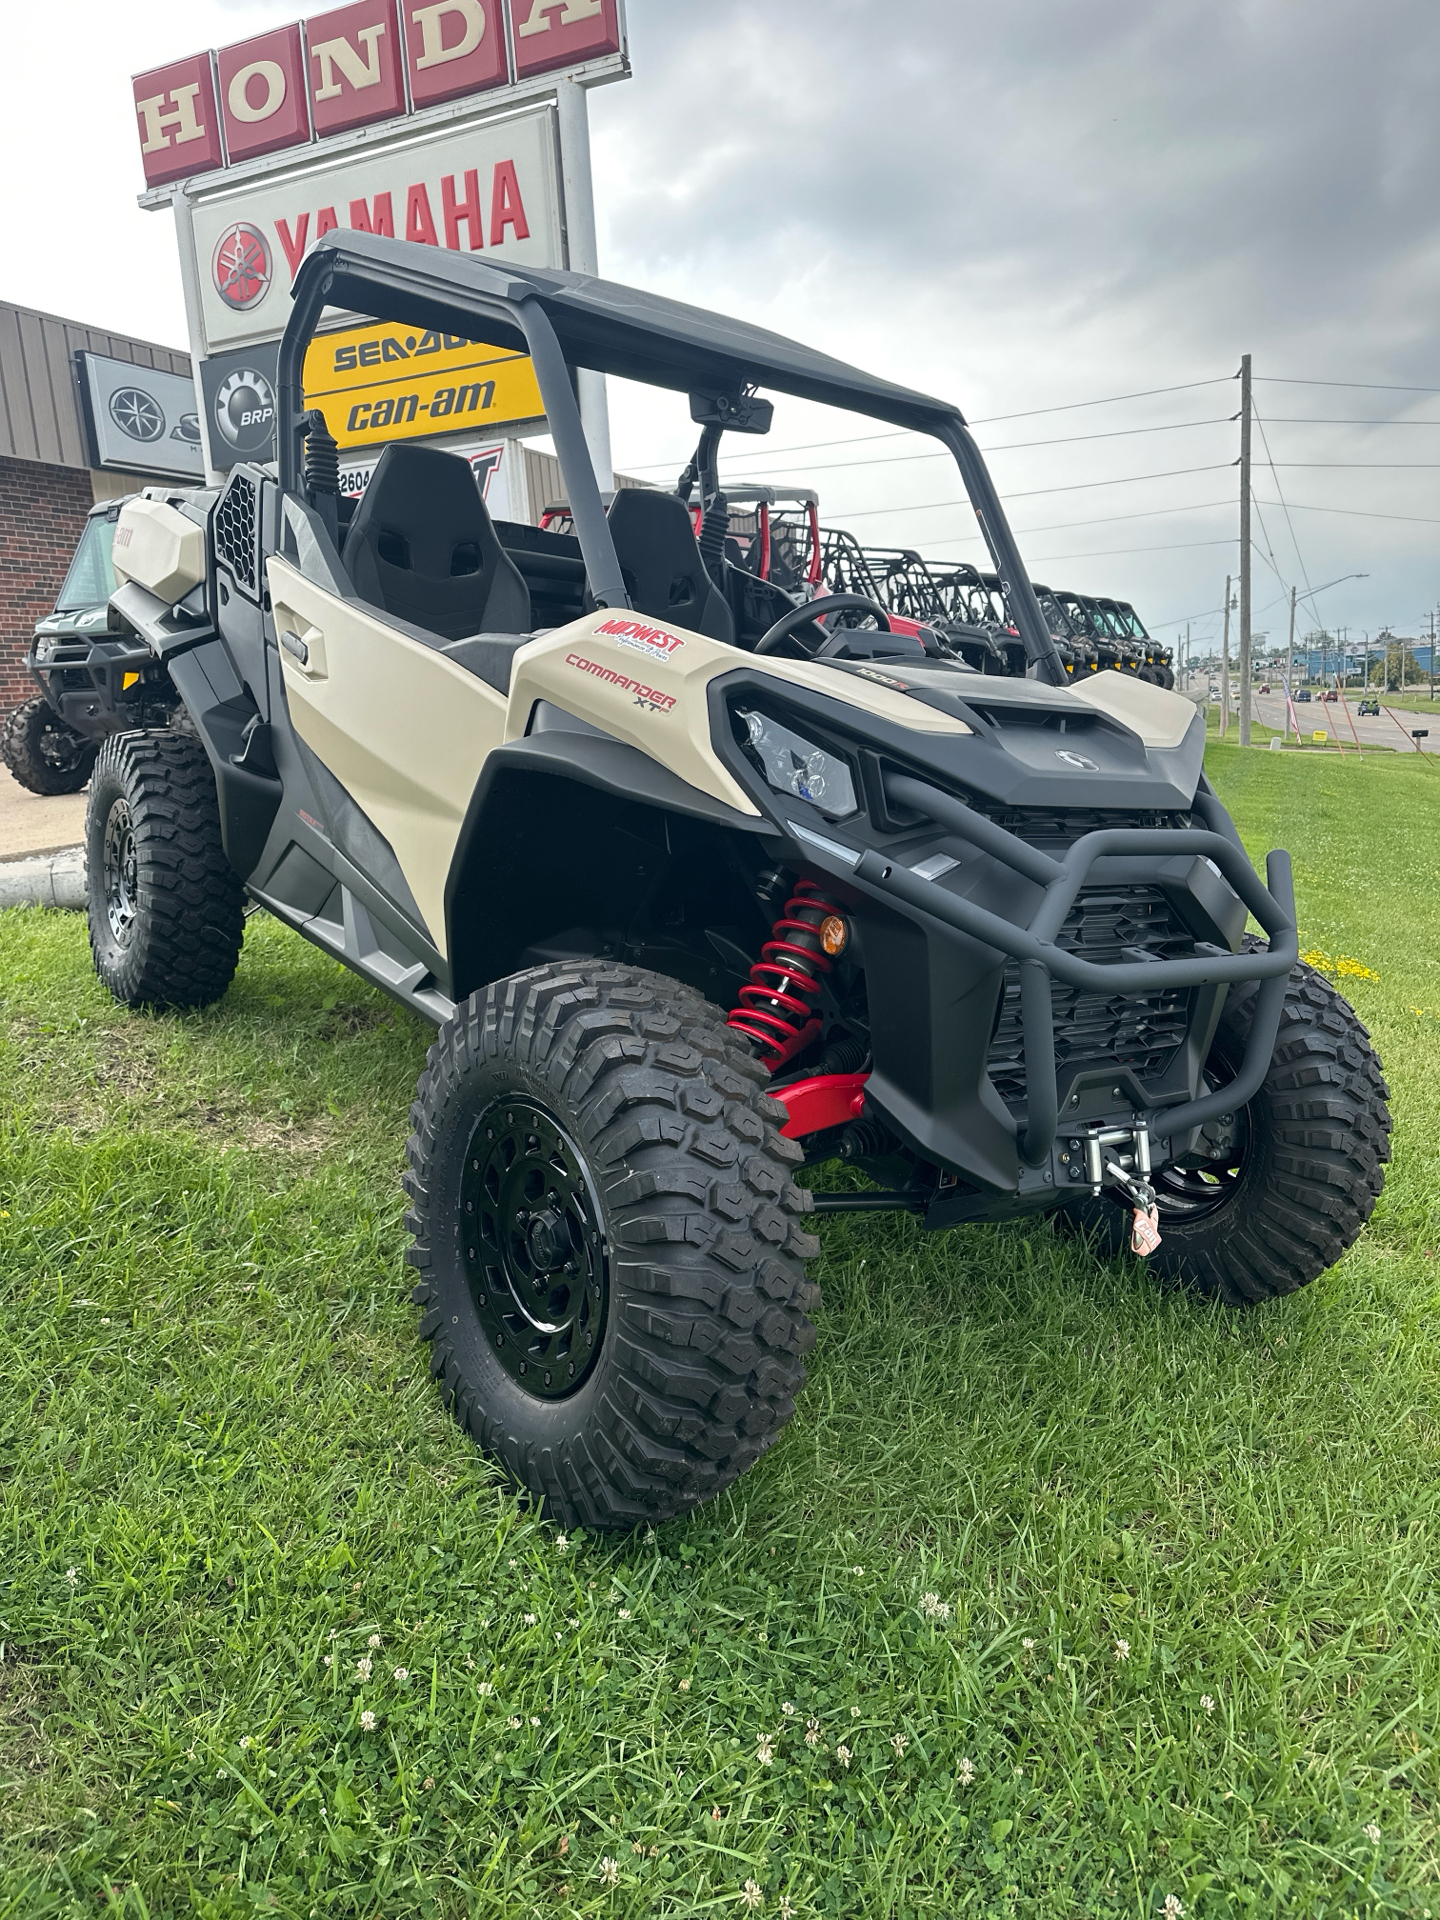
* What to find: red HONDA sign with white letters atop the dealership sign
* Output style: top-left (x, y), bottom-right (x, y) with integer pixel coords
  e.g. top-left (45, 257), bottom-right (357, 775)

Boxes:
top-left (134, 0), bottom-right (624, 186)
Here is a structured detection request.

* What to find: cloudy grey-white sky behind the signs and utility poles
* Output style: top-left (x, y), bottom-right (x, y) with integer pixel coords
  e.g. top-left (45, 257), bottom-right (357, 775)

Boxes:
top-left (0, 0), bottom-right (1440, 645)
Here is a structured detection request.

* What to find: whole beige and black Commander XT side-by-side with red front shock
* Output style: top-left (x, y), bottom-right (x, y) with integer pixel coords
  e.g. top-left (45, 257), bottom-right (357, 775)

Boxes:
top-left (2, 232), bottom-right (1390, 1528)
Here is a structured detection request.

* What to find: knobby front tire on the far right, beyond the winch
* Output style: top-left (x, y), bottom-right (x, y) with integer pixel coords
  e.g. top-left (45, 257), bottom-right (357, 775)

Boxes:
top-left (1060, 937), bottom-right (1390, 1306)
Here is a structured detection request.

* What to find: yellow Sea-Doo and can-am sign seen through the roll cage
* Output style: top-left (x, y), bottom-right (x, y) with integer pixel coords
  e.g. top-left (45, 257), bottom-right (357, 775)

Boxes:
top-left (305, 326), bottom-right (545, 447)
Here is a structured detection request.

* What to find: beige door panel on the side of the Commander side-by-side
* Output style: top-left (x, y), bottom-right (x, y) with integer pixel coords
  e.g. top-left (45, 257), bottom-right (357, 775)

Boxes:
top-left (267, 559), bottom-right (505, 958)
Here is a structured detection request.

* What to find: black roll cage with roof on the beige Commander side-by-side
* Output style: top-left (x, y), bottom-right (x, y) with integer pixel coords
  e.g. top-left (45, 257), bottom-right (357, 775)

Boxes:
top-left (278, 230), bottom-right (1066, 685)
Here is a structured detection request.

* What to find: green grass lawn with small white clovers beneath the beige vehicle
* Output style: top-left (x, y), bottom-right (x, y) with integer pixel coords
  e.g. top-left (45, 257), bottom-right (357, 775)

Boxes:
top-left (0, 747), bottom-right (1440, 1920)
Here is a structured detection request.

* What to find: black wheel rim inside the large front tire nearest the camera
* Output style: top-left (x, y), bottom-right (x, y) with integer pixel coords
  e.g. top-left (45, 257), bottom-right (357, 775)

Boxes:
top-left (461, 1098), bottom-right (609, 1400)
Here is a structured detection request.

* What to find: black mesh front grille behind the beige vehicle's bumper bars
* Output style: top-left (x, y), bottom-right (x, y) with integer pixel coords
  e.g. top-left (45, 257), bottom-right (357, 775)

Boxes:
top-left (972, 803), bottom-right (1194, 1112)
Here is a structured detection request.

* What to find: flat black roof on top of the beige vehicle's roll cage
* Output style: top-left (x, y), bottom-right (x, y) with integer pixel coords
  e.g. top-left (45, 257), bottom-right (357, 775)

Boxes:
top-left (294, 228), bottom-right (962, 432)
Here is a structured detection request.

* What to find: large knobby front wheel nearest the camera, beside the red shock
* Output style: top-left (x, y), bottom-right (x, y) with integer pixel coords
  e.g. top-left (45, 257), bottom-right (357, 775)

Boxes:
top-left (405, 962), bottom-right (818, 1528)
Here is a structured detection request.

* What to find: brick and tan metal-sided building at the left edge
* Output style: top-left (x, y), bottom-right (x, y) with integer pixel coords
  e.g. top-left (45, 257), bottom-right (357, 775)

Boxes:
top-left (0, 301), bottom-right (190, 712)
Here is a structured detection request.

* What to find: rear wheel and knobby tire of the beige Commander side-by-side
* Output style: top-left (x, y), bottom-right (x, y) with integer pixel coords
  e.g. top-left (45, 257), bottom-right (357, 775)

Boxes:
top-left (84, 732), bottom-right (246, 1008)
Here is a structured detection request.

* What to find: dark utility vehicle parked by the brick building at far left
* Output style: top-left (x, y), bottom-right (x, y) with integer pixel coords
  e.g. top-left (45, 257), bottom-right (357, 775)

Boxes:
top-left (0, 499), bottom-right (175, 795)
